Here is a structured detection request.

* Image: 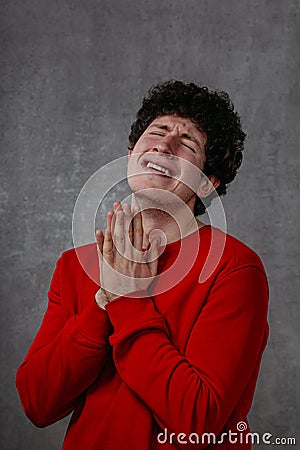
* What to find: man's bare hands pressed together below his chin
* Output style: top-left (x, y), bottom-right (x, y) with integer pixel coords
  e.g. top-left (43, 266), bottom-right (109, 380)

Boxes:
top-left (96, 202), bottom-right (160, 301)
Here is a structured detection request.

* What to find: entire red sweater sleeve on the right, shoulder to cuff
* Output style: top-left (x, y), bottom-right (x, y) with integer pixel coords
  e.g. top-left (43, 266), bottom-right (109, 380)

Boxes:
top-left (106, 267), bottom-right (268, 449)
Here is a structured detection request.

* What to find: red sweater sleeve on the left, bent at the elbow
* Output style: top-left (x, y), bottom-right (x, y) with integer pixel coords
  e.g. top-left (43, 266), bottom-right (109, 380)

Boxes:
top-left (16, 257), bottom-right (111, 427)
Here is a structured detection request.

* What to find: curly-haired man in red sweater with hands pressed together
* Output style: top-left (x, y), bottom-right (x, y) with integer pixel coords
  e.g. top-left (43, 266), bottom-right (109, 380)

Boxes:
top-left (17, 81), bottom-right (268, 450)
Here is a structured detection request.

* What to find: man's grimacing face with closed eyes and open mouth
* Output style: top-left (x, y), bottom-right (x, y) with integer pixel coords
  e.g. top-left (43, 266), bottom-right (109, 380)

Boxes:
top-left (128, 115), bottom-right (206, 209)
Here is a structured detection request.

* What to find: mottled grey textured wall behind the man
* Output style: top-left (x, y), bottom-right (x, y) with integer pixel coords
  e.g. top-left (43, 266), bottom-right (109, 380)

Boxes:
top-left (0, 0), bottom-right (300, 450)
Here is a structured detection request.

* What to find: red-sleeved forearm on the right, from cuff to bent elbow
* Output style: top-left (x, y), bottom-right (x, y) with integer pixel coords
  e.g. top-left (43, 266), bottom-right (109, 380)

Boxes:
top-left (106, 298), bottom-right (227, 440)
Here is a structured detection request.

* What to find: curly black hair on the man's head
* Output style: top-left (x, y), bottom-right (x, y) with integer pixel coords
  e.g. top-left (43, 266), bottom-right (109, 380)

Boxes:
top-left (129, 80), bottom-right (246, 216)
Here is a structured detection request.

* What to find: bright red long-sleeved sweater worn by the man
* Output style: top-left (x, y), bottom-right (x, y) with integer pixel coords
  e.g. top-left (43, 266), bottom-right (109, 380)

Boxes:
top-left (17, 226), bottom-right (268, 450)
